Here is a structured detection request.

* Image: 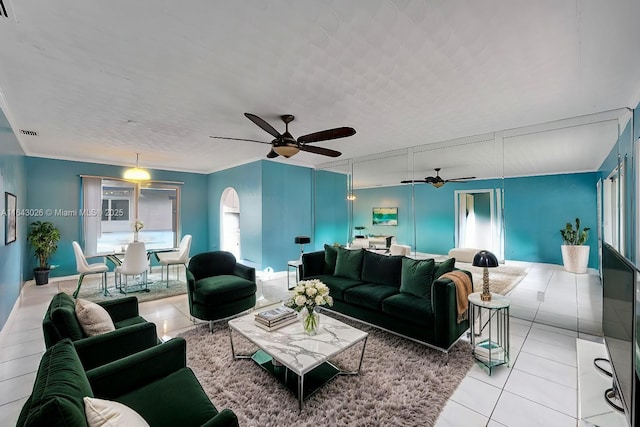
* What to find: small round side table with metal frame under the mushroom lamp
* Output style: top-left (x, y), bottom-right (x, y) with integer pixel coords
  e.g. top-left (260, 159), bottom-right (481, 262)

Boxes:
top-left (469, 292), bottom-right (509, 375)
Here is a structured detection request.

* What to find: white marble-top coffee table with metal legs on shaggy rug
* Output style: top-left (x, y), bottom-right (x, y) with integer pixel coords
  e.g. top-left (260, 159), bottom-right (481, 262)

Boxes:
top-left (229, 313), bottom-right (368, 409)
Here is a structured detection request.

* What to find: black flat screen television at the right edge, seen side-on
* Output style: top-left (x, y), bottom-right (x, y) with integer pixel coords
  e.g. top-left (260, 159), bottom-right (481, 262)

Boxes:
top-left (602, 243), bottom-right (638, 426)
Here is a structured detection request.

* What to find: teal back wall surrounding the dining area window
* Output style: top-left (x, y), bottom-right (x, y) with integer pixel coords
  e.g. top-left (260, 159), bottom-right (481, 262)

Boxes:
top-left (24, 157), bottom-right (209, 279)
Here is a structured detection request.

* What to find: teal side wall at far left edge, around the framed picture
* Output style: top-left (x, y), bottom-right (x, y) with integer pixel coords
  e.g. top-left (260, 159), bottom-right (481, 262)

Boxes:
top-left (0, 111), bottom-right (27, 328)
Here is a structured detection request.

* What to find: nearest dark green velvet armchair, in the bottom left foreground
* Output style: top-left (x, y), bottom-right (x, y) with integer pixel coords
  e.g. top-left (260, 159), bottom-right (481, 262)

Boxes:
top-left (16, 338), bottom-right (238, 427)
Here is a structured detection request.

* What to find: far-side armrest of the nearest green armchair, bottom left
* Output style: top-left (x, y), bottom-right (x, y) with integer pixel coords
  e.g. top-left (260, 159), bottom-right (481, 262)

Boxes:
top-left (87, 338), bottom-right (187, 400)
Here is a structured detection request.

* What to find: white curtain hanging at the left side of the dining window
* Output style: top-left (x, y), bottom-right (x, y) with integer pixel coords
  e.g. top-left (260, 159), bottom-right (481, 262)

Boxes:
top-left (81, 177), bottom-right (102, 256)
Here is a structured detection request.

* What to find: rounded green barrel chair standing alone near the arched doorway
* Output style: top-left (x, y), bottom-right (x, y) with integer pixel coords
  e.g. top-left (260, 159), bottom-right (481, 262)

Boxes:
top-left (187, 251), bottom-right (257, 328)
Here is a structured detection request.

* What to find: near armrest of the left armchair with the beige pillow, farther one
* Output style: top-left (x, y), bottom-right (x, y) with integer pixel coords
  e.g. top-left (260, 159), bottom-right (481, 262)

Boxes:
top-left (73, 322), bottom-right (158, 371)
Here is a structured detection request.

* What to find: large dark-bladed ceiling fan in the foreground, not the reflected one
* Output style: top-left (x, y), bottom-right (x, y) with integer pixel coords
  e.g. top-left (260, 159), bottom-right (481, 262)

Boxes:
top-left (211, 113), bottom-right (356, 159)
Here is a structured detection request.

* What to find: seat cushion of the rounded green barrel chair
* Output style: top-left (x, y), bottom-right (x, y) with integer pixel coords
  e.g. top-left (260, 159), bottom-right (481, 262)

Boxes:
top-left (192, 274), bottom-right (256, 306)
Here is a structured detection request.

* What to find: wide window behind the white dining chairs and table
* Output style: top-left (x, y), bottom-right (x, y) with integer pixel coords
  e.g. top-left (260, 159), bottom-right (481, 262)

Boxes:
top-left (82, 177), bottom-right (180, 255)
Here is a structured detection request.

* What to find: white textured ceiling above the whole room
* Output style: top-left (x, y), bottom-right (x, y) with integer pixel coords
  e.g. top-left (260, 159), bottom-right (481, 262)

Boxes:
top-left (0, 0), bottom-right (640, 180)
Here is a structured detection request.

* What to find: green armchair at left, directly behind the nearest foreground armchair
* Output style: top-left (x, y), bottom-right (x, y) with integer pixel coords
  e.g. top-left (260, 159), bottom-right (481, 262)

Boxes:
top-left (42, 292), bottom-right (159, 369)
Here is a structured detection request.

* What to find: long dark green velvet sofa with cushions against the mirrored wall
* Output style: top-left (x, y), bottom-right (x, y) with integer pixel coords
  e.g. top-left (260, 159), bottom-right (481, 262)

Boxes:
top-left (302, 245), bottom-right (471, 352)
